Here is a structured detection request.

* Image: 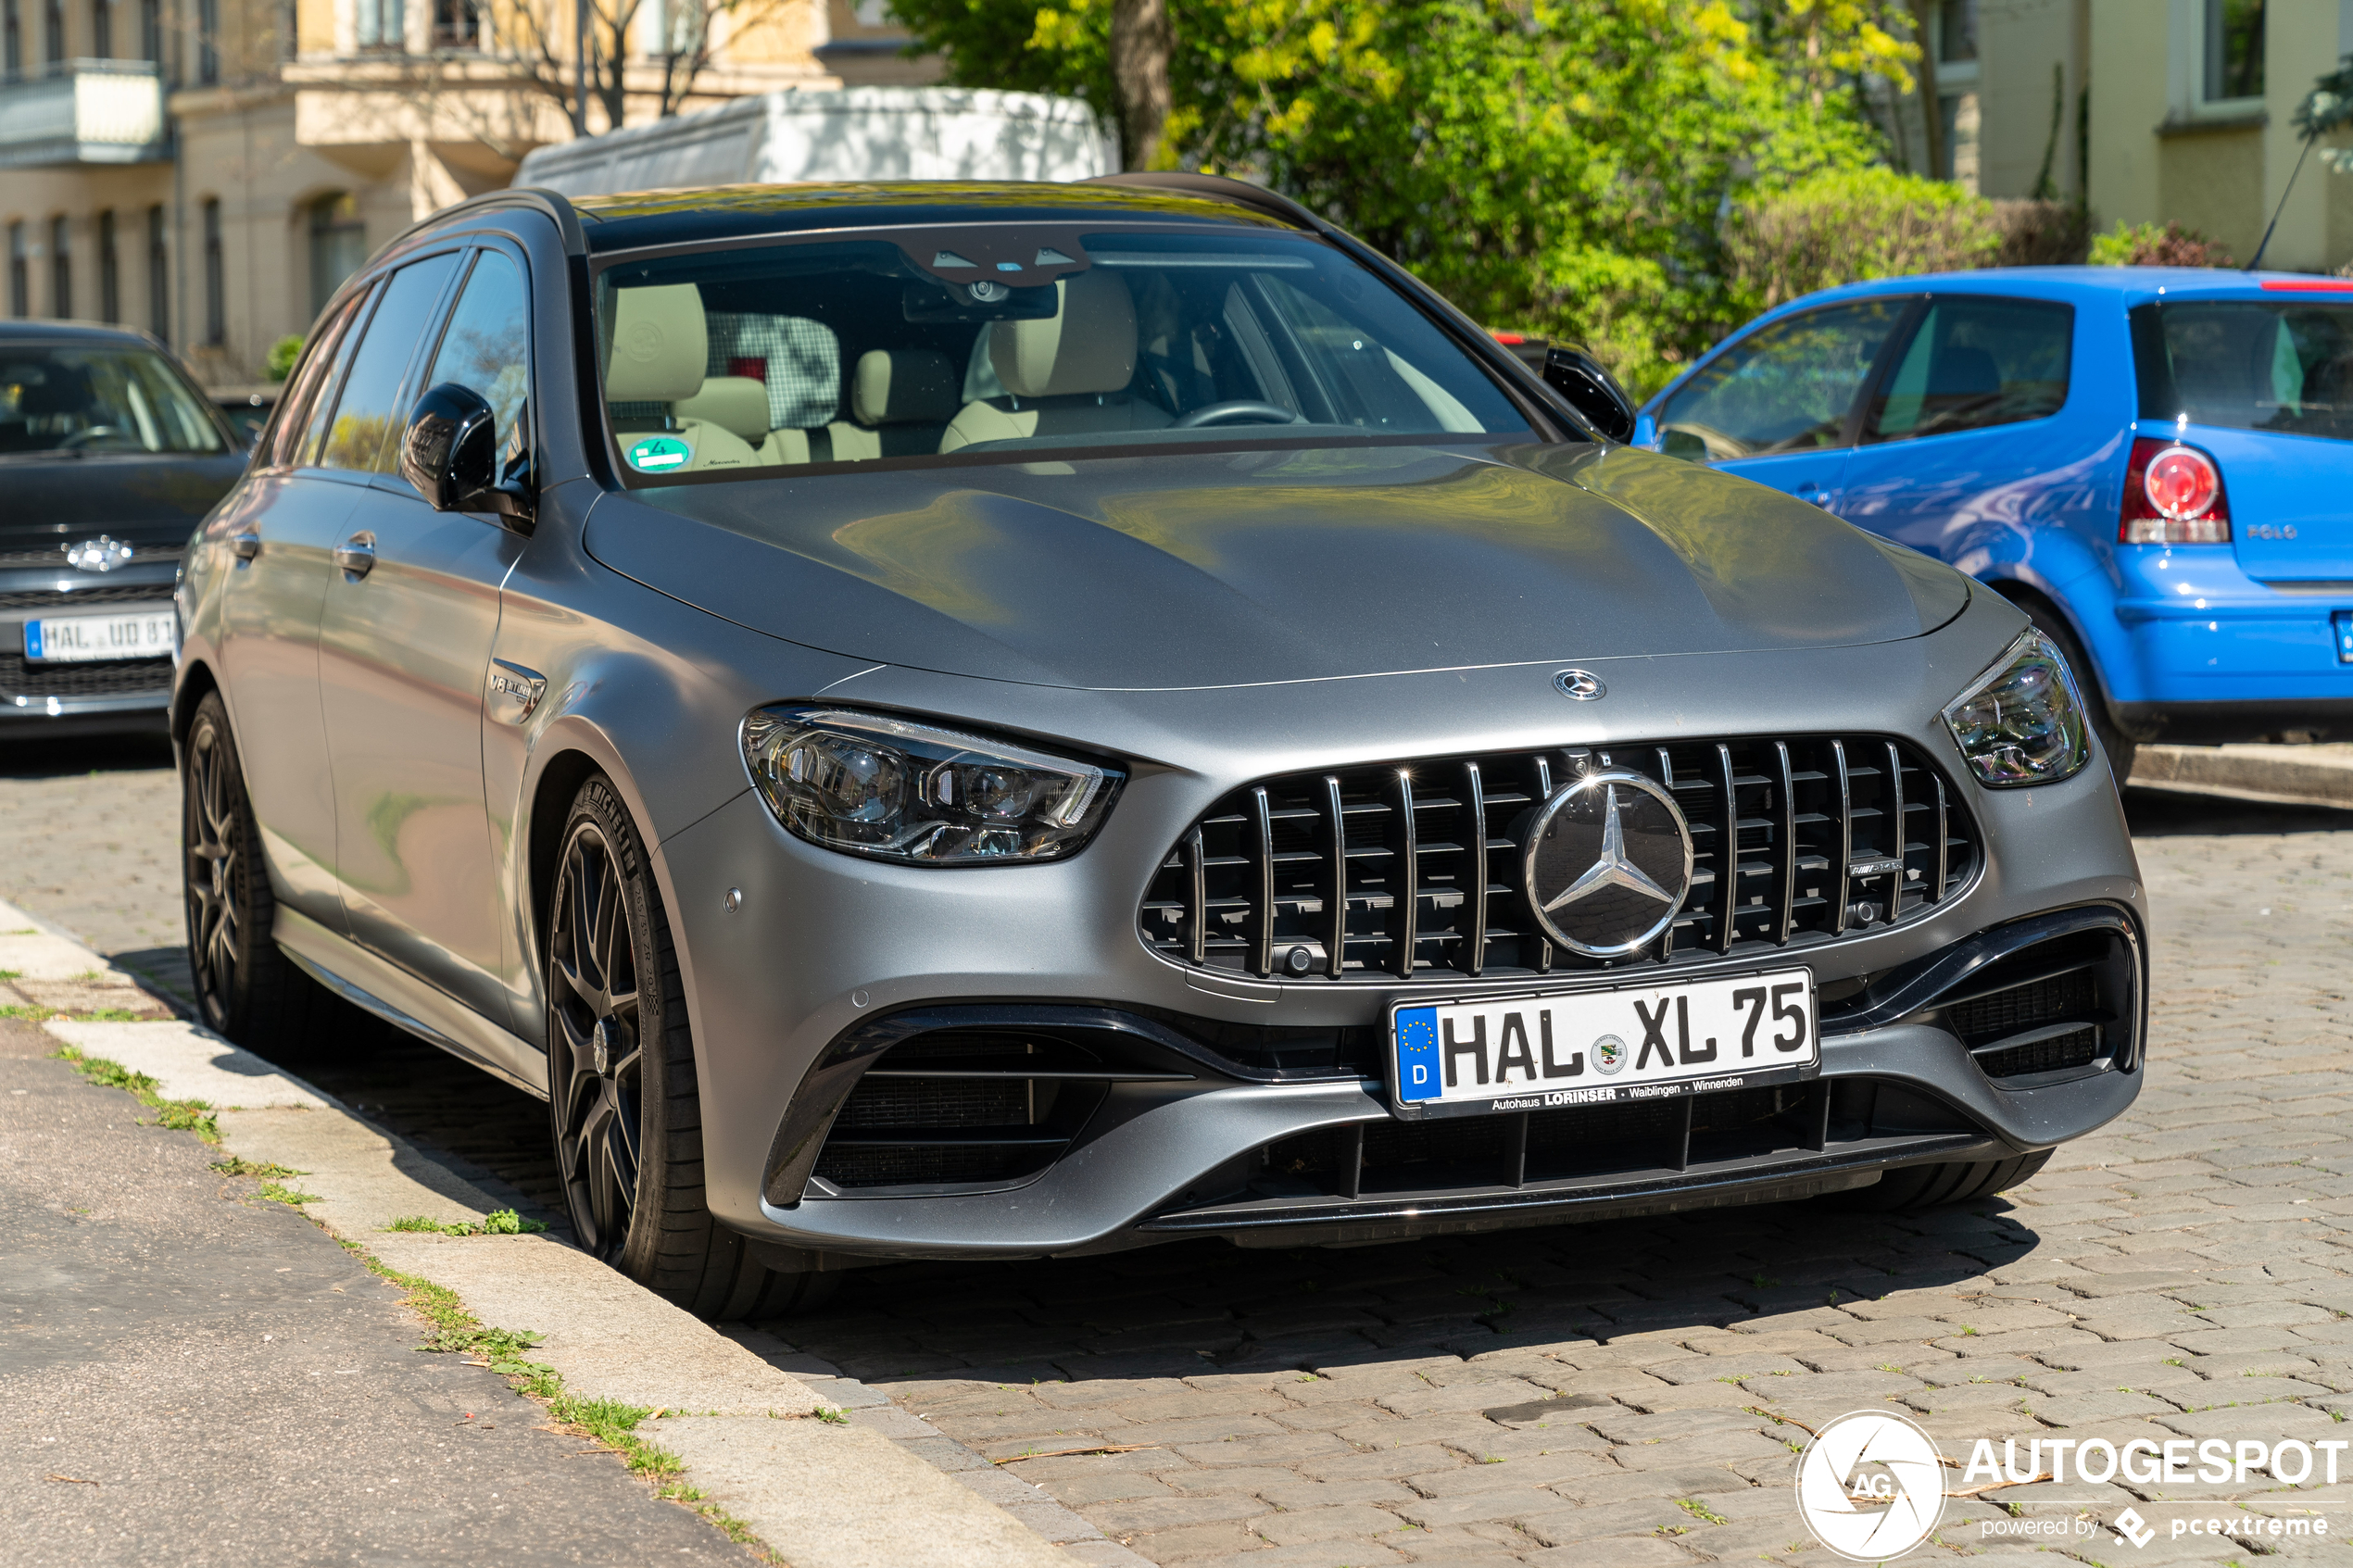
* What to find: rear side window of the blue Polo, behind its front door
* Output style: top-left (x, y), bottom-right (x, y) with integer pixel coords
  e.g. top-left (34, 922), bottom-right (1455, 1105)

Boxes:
top-left (1869, 298), bottom-right (2075, 442)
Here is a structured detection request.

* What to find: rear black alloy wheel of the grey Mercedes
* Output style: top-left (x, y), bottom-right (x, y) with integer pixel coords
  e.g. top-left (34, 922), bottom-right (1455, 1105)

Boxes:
top-left (179, 691), bottom-right (338, 1062)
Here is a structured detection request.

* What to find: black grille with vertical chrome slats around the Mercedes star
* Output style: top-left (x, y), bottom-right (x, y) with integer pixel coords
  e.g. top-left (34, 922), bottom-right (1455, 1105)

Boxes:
top-left (1139, 735), bottom-right (1979, 983)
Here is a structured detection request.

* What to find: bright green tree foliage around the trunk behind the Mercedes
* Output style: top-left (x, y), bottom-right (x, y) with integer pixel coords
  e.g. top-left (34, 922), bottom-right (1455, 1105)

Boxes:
top-left (892, 0), bottom-right (1918, 388)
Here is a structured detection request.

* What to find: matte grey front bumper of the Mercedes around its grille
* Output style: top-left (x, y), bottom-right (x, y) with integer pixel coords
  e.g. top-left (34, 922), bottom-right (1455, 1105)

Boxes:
top-left (659, 616), bottom-right (2145, 1258)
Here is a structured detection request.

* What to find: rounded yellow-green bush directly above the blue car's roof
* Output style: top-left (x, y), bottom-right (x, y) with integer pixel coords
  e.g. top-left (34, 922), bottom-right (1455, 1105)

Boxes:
top-left (1725, 169), bottom-right (2003, 310)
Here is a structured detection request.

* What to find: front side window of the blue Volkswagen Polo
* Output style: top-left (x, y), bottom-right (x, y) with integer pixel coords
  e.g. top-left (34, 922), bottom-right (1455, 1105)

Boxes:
top-left (1659, 298), bottom-right (1910, 460)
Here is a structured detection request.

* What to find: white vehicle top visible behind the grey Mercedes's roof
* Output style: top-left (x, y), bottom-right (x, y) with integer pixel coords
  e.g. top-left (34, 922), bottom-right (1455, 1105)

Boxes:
top-left (515, 87), bottom-right (1120, 195)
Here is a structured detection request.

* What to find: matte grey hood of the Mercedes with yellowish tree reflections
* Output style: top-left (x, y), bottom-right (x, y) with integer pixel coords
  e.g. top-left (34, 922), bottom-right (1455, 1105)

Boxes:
top-left (585, 446), bottom-right (1969, 689)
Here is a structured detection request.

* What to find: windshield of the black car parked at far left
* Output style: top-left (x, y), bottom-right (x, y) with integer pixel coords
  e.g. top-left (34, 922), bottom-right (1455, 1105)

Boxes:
top-left (0, 344), bottom-right (228, 456)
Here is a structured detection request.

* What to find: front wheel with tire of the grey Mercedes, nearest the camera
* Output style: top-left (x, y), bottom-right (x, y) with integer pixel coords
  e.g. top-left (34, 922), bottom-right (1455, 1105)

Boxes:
top-left (546, 778), bottom-right (836, 1319)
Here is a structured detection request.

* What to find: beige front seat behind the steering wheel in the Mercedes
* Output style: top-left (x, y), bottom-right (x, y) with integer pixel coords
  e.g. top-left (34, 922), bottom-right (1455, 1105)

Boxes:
top-left (938, 268), bottom-right (1174, 451)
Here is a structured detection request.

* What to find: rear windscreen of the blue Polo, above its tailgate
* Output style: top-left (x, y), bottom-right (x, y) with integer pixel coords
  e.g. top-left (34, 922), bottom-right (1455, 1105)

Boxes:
top-left (2132, 298), bottom-right (2353, 442)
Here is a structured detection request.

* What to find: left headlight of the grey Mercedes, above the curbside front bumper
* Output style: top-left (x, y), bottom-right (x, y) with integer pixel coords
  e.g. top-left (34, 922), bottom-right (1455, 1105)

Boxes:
top-left (744, 708), bottom-right (1125, 865)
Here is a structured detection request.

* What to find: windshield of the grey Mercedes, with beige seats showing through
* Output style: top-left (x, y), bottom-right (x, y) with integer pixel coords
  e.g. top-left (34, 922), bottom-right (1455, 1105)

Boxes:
top-left (598, 223), bottom-right (1529, 482)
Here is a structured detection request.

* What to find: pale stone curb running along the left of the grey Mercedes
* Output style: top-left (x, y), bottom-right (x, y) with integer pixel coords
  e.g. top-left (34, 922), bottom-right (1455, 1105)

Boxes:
top-left (0, 903), bottom-right (1087, 1568)
